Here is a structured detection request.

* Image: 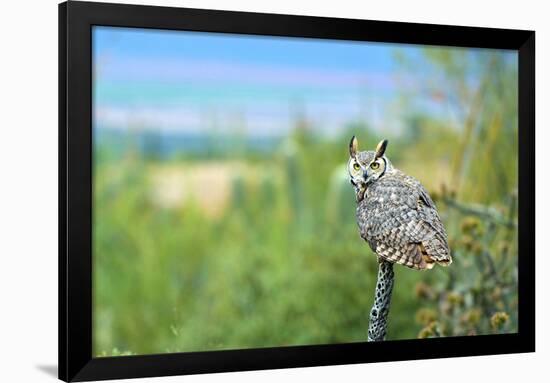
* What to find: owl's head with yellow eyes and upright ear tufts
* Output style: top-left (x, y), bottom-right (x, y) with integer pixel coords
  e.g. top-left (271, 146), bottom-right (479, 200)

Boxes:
top-left (348, 136), bottom-right (393, 202)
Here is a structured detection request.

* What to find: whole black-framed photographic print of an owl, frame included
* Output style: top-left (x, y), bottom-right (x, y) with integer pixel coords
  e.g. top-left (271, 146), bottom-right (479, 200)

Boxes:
top-left (59, 1), bottom-right (535, 381)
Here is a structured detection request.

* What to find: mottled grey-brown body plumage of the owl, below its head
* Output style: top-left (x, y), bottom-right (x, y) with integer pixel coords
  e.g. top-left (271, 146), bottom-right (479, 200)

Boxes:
top-left (357, 170), bottom-right (451, 269)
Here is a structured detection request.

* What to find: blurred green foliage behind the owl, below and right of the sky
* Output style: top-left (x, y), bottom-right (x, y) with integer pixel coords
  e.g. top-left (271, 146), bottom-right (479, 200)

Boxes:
top-left (93, 50), bottom-right (517, 356)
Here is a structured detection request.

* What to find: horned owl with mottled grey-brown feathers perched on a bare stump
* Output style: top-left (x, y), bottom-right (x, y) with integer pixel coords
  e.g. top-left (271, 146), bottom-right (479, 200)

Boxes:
top-left (348, 136), bottom-right (452, 270)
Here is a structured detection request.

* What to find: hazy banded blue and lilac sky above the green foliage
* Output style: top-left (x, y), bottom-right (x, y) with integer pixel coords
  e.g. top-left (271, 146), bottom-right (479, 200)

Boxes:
top-left (93, 27), bottom-right (516, 135)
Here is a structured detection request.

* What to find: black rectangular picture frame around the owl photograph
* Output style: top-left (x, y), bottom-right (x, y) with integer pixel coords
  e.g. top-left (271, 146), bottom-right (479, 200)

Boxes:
top-left (59, 1), bottom-right (535, 381)
